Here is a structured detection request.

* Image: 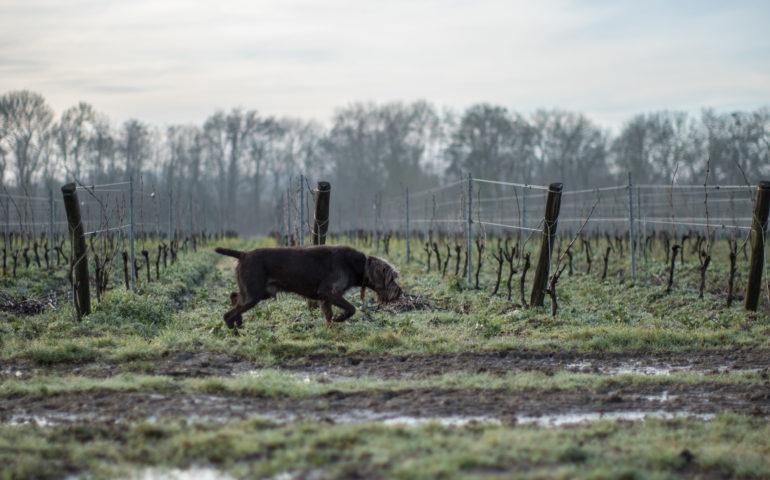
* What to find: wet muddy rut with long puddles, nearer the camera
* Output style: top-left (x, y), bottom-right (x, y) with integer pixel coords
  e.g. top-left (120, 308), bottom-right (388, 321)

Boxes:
top-left (0, 385), bottom-right (770, 426)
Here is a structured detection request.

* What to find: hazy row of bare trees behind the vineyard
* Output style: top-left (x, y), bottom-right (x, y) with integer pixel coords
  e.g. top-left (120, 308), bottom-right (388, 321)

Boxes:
top-left (0, 90), bottom-right (770, 233)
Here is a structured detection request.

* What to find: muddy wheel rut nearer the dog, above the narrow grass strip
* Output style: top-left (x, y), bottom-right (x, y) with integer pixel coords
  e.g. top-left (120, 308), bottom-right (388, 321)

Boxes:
top-left (0, 350), bottom-right (770, 380)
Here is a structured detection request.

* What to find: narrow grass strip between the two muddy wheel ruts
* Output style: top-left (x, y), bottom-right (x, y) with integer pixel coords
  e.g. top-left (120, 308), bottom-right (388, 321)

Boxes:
top-left (0, 368), bottom-right (768, 398)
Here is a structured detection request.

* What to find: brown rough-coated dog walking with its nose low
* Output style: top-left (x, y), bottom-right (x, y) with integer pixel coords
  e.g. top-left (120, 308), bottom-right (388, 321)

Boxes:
top-left (215, 246), bottom-right (401, 328)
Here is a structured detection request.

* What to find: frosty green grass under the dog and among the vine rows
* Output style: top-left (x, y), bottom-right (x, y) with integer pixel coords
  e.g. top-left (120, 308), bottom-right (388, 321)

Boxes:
top-left (0, 233), bottom-right (770, 365)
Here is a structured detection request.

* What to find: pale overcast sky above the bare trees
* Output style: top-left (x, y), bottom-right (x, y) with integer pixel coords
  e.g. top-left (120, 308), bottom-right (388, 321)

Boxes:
top-left (0, 0), bottom-right (770, 128)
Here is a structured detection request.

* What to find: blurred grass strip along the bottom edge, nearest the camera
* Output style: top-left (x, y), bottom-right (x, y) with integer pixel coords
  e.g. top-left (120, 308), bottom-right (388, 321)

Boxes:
top-left (0, 413), bottom-right (770, 479)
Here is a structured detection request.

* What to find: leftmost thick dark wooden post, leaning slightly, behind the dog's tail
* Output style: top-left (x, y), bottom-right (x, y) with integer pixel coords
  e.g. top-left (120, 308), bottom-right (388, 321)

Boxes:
top-left (61, 183), bottom-right (91, 318)
